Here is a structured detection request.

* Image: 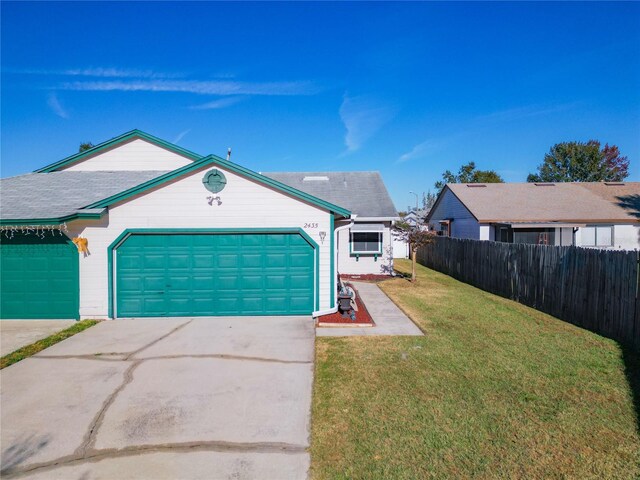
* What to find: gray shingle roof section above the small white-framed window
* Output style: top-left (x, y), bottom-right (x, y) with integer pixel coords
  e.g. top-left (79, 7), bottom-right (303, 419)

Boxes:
top-left (262, 172), bottom-right (398, 218)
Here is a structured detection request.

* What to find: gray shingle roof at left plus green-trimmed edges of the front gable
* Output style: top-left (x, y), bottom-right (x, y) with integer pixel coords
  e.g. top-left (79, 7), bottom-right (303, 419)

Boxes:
top-left (0, 155), bottom-right (351, 224)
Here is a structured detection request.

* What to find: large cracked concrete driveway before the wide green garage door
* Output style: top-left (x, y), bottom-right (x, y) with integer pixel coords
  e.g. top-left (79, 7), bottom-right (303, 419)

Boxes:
top-left (0, 317), bottom-right (314, 480)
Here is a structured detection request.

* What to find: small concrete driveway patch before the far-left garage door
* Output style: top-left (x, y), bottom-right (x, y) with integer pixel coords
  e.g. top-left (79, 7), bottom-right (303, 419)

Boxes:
top-left (0, 320), bottom-right (76, 356)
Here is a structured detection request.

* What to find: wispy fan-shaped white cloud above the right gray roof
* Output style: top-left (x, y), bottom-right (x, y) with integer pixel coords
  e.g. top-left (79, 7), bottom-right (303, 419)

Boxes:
top-left (339, 94), bottom-right (394, 153)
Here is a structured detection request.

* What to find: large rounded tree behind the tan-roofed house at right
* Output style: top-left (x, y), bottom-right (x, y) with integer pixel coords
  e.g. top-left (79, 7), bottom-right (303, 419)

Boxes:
top-left (527, 140), bottom-right (629, 182)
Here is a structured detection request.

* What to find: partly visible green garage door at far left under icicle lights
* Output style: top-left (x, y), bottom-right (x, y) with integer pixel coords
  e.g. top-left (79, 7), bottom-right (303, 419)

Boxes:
top-left (0, 233), bottom-right (79, 319)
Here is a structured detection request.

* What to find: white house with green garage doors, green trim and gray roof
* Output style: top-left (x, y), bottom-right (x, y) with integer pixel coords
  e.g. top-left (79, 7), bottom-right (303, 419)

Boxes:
top-left (0, 130), bottom-right (397, 319)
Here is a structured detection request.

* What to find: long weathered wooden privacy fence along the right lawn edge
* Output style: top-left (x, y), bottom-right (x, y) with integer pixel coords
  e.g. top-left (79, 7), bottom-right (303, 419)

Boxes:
top-left (417, 237), bottom-right (640, 350)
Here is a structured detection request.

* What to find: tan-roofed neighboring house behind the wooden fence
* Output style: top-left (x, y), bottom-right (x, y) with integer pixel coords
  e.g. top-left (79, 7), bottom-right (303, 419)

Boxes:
top-left (427, 182), bottom-right (640, 250)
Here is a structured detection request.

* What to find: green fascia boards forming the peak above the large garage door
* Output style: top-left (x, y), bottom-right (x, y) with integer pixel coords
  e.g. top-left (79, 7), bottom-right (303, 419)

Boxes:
top-left (84, 155), bottom-right (351, 218)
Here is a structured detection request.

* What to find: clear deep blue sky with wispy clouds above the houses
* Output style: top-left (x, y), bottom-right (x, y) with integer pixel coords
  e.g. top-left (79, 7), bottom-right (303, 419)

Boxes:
top-left (0, 2), bottom-right (640, 209)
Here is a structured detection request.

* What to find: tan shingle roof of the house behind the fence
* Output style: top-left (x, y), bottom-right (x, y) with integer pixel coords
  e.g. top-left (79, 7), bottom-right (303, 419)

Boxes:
top-left (427, 182), bottom-right (640, 223)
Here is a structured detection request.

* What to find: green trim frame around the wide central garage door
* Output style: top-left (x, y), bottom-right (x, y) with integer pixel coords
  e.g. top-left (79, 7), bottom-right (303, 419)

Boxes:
top-left (107, 227), bottom-right (320, 318)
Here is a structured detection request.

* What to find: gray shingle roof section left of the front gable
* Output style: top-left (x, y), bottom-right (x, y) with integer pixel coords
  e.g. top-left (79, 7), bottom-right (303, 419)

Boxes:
top-left (0, 170), bottom-right (166, 220)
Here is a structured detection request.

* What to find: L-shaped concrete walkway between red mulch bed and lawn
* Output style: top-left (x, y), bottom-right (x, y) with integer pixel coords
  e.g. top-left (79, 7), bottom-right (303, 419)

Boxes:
top-left (316, 281), bottom-right (423, 337)
